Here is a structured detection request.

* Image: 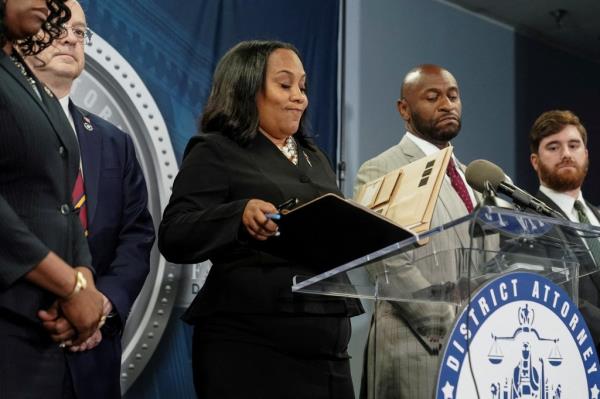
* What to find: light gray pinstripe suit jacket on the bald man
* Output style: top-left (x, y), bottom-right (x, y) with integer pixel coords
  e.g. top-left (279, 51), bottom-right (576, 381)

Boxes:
top-left (355, 137), bottom-right (479, 399)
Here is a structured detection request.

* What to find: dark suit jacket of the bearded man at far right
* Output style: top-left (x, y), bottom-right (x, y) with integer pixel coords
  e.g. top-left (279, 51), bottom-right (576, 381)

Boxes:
top-left (535, 191), bottom-right (600, 347)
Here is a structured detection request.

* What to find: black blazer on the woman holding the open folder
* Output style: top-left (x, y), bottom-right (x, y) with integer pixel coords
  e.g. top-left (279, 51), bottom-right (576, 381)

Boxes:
top-left (158, 133), bottom-right (362, 322)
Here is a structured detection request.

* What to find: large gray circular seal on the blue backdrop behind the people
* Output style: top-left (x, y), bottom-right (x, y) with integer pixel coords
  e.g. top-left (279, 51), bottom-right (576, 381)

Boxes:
top-left (71, 33), bottom-right (180, 393)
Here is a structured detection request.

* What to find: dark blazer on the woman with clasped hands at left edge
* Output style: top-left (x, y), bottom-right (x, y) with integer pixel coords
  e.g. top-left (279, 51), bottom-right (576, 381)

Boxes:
top-left (0, 51), bottom-right (91, 324)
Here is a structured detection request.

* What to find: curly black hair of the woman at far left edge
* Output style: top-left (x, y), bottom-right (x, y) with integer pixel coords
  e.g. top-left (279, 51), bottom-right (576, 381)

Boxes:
top-left (0, 0), bottom-right (71, 55)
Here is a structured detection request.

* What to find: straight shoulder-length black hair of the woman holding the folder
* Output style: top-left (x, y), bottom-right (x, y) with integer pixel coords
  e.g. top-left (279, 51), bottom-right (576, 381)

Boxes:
top-left (200, 40), bottom-right (314, 149)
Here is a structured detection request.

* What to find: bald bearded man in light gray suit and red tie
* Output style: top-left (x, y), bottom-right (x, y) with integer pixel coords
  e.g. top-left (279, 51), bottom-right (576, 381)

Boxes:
top-left (355, 65), bottom-right (478, 399)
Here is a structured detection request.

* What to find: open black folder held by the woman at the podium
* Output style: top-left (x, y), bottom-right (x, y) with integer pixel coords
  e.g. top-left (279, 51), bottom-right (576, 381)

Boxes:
top-left (264, 194), bottom-right (414, 270)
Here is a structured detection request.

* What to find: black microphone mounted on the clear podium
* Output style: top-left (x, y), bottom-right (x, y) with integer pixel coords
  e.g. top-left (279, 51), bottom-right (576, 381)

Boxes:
top-left (465, 159), bottom-right (564, 219)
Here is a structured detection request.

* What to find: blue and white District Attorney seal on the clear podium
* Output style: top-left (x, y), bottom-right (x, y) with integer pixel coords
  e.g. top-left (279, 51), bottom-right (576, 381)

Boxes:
top-left (436, 272), bottom-right (600, 399)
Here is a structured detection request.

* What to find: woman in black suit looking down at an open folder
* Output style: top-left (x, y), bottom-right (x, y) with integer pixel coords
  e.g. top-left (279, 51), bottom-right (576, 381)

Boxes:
top-left (159, 41), bottom-right (362, 399)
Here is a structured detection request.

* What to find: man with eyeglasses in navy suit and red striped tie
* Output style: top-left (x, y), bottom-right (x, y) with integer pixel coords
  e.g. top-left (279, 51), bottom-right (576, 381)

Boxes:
top-left (26, 0), bottom-right (154, 399)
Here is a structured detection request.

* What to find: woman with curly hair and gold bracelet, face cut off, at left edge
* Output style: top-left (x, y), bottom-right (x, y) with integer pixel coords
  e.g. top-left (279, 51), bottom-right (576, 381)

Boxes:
top-left (0, 0), bottom-right (102, 399)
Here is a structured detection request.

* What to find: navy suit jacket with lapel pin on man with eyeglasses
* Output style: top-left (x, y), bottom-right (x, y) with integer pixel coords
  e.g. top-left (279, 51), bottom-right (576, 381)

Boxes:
top-left (69, 102), bottom-right (154, 399)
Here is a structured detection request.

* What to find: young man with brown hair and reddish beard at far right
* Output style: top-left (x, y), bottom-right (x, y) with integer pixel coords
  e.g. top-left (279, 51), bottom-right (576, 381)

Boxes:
top-left (529, 111), bottom-right (600, 347)
